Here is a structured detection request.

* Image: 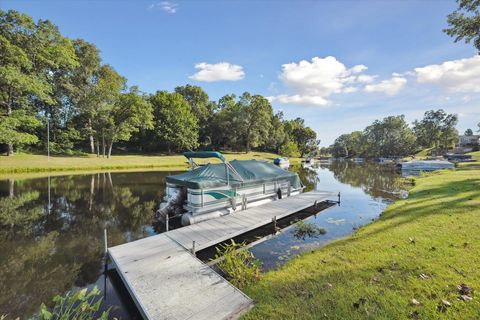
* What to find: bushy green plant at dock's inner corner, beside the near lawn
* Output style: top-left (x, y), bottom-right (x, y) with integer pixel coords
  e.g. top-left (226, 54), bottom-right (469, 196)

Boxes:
top-left (214, 240), bottom-right (261, 289)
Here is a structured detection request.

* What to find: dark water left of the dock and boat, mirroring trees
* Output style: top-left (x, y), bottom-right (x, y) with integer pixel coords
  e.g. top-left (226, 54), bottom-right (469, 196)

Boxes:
top-left (0, 172), bottom-right (171, 318)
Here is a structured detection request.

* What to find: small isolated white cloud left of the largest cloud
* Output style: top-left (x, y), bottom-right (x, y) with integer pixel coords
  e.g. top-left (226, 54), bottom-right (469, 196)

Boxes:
top-left (189, 62), bottom-right (245, 82)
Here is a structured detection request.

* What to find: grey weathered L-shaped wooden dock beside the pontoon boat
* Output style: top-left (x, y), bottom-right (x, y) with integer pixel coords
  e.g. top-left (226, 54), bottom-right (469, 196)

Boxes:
top-left (108, 191), bottom-right (335, 320)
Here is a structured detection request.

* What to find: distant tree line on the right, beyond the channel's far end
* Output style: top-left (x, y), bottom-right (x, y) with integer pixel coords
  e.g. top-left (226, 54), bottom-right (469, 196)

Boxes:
top-left (322, 109), bottom-right (464, 158)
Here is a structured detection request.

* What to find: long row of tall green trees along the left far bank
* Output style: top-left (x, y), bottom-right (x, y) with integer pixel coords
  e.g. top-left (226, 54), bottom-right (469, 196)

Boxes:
top-left (0, 10), bottom-right (319, 157)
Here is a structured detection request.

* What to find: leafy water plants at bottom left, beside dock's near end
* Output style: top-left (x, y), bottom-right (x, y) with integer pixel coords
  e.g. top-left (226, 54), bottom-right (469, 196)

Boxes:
top-left (32, 287), bottom-right (111, 320)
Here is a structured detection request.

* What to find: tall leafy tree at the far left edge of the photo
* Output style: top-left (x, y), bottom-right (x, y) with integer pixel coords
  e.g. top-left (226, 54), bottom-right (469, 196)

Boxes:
top-left (0, 10), bottom-right (51, 155)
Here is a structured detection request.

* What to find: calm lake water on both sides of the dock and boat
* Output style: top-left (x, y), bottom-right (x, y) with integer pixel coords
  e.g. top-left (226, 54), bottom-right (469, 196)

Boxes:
top-left (0, 162), bottom-right (402, 319)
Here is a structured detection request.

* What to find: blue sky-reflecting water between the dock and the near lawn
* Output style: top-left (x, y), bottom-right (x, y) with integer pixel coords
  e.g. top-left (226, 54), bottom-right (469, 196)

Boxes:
top-left (250, 161), bottom-right (404, 271)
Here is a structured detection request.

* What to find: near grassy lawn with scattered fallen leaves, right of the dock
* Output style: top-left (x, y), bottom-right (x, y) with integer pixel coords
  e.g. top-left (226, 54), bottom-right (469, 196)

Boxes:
top-left (244, 152), bottom-right (480, 319)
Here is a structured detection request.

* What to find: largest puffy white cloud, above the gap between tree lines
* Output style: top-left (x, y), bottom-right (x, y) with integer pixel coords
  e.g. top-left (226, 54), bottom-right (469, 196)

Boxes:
top-left (270, 56), bottom-right (375, 106)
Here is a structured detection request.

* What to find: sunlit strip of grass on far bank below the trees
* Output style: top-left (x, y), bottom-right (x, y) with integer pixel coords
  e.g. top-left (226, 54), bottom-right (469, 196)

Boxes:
top-left (0, 152), bottom-right (298, 174)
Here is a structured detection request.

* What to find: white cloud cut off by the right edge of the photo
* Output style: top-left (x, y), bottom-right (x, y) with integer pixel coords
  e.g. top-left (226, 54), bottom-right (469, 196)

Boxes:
top-left (415, 55), bottom-right (480, 92)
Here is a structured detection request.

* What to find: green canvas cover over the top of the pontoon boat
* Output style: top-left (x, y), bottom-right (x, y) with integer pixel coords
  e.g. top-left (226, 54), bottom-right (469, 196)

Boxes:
top-left (167, 160), bottom-right (302, 189)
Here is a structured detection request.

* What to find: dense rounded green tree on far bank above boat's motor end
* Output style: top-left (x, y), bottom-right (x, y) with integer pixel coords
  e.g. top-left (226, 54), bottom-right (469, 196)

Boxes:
top-left (149, 91), bottom-right (198, 153)
